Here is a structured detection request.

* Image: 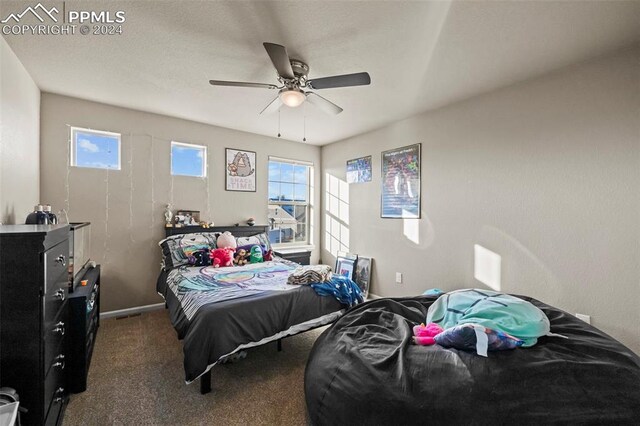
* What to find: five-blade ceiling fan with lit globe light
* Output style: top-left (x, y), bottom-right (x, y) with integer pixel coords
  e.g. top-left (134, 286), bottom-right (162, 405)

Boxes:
top-left (209, 43), bottom-right (371, 114)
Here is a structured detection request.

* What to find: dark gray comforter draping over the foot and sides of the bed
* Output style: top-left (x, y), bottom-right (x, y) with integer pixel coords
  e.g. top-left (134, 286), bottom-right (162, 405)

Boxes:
top-left (157, 262), bottom-right (344, 383)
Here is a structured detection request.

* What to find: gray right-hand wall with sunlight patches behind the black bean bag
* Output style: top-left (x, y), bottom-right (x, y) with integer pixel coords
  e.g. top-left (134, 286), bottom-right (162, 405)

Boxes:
top-left (321, 49), bottom-right (640, 353)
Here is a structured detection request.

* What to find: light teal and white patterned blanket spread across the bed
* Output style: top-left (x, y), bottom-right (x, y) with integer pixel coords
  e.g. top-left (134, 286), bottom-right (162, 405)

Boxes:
top-left (167, 261), bottom-right (296, 320)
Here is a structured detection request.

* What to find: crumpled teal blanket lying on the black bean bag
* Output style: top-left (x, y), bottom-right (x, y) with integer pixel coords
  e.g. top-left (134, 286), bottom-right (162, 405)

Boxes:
top-left (426, 289), bottom-right (550, 347)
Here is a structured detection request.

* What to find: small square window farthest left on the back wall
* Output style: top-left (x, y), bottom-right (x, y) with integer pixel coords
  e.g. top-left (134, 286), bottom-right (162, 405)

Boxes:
top-left (71, 127), bottom-right (120, 170)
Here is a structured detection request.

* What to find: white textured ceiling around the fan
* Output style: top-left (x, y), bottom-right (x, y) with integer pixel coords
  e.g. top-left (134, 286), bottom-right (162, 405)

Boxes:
top-left (0, 0), bottom-right (640, 145)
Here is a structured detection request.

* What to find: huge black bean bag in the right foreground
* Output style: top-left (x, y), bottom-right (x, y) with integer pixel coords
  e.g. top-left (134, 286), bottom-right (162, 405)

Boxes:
top-left (305, 296), bottom-right (640, 426)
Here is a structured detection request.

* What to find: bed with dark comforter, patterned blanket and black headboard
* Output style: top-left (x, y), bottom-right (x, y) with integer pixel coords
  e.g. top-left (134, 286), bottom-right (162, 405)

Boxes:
top-left (157, 226), bottom-right (345, 393)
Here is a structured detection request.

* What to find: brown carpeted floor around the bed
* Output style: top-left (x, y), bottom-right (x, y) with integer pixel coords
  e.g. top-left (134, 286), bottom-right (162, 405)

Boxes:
top-left (64, 310), bottom-right (323, 426)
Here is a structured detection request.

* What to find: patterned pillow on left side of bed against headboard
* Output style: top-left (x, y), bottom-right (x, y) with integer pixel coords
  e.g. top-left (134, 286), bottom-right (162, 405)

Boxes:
top-left (158, 232), bottom-right (219, 271)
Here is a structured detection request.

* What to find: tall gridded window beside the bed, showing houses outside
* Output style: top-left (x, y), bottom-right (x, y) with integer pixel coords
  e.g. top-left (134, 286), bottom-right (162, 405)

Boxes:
top-left (268, 157), bottom-right (313, 245)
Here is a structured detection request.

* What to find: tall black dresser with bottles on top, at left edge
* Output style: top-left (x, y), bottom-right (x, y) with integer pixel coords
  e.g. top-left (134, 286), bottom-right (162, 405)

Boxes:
top-left (0, 225), bottom-right (69, 425)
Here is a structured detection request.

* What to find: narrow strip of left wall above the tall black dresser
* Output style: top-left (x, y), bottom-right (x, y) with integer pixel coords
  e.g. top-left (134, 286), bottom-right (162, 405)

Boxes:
top-left (0, 37), bottom-right (40, 224)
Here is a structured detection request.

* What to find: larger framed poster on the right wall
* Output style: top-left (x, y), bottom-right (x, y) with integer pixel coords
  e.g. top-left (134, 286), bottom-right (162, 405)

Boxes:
top-left (380, 143), bottom-right (421, 219)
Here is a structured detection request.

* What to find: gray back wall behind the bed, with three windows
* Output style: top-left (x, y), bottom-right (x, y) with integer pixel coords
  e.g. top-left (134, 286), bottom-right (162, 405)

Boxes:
top-left (40, 93), bottom-right (320, 311)
